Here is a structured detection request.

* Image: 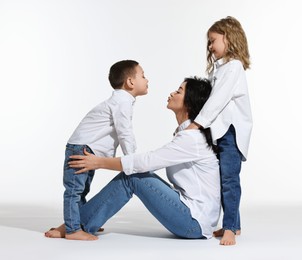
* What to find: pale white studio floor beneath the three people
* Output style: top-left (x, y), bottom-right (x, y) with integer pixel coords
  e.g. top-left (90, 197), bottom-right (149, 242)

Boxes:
top-left (0, 204), bottom-right (302, 260)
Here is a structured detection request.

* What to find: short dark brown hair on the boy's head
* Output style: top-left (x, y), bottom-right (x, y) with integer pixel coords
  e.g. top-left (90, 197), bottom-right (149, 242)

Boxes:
top-left (108, 60), bottom-right (139, 89)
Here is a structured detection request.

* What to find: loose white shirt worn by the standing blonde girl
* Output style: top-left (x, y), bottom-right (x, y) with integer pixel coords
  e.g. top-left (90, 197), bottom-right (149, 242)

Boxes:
top-left (194, 59), bottom-right (253, 161)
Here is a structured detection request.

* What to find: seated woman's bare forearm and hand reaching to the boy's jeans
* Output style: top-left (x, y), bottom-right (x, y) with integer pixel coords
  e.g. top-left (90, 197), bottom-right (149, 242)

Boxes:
top-left (68, 149), bottom-right (122, 173)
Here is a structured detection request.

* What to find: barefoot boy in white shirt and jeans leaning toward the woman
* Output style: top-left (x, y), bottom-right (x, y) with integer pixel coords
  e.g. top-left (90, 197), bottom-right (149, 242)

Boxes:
top-left (45, 60), bottom-right (148, 240)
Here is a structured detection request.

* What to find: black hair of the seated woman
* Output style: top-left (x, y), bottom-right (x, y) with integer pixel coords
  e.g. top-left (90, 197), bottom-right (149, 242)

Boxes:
top-left (184, 76), bottom-right (218, 153)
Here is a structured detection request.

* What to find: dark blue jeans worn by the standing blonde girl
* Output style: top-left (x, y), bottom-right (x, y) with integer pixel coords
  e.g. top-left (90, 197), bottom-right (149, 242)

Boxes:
top-left (217, 125), bottom-right (242, 232)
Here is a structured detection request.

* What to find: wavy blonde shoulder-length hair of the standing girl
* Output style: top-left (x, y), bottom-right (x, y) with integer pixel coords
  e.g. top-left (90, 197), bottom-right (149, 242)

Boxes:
top-left (206, 16), bottom-right (250, 73)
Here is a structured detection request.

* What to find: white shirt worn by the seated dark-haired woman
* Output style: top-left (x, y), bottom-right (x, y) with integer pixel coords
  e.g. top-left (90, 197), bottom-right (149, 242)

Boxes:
top-left (121, 120), bottom-right (220, 238)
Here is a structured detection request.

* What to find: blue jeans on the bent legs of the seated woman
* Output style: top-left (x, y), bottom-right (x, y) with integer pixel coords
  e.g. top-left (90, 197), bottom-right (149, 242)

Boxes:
top-left (80, 172), bottom-right (204, 238)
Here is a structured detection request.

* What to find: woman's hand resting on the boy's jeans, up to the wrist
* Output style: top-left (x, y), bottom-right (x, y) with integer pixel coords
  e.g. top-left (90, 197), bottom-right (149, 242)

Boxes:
top-left (68, 149), bottom-right (101, 174)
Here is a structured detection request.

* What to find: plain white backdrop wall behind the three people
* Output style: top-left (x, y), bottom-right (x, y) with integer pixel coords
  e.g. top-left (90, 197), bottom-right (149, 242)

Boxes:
top-left (0, 0), bottom-right (302, 206)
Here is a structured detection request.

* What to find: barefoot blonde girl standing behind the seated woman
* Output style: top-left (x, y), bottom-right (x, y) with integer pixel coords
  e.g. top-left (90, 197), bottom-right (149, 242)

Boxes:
top-left (188, 16), bottom-right (252, 245)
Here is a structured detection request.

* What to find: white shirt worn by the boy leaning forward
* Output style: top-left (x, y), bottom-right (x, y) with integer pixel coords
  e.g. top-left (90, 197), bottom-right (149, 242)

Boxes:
top-left (68, 89), bottom-right (136, 157)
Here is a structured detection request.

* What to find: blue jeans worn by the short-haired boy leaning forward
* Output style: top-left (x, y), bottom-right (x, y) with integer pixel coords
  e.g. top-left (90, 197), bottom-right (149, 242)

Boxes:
top-left (63, 144), bottom-right (94, 234)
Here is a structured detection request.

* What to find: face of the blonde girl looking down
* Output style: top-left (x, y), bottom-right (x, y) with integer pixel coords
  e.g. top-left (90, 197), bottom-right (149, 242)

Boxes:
top-left (208, 32), bottom-right (227, 60)
